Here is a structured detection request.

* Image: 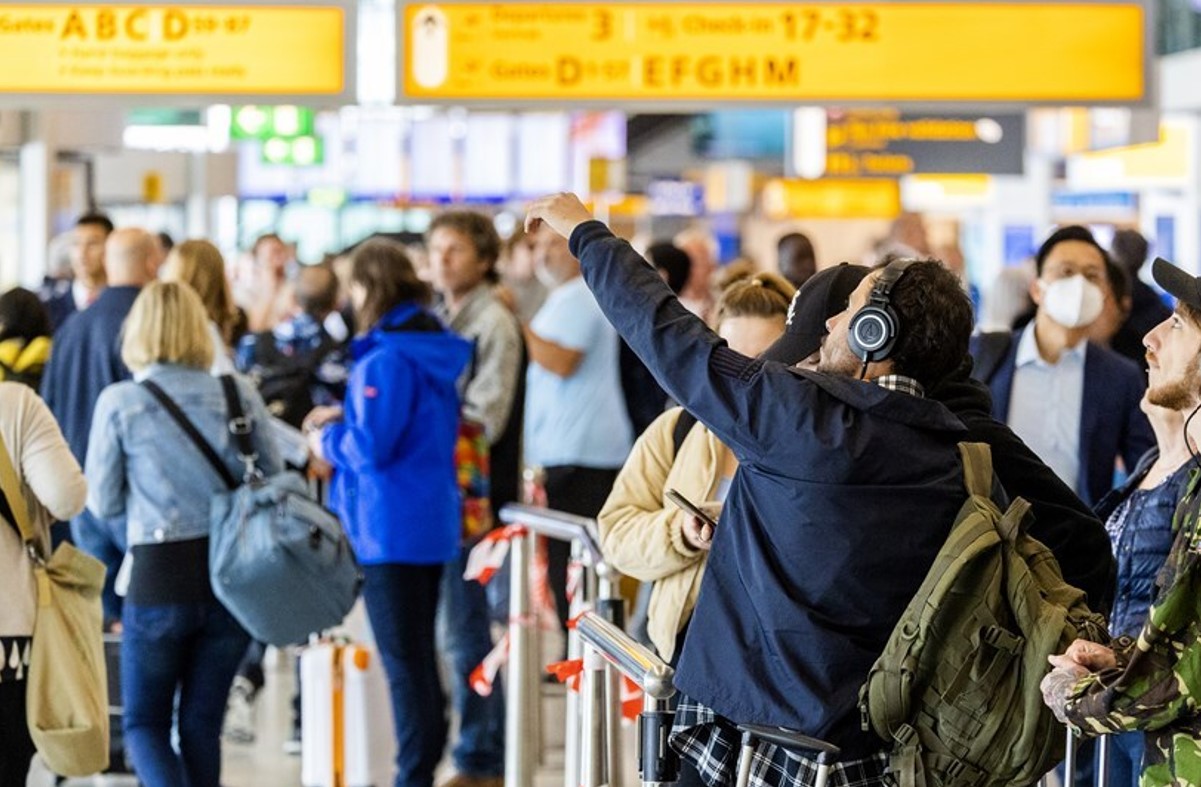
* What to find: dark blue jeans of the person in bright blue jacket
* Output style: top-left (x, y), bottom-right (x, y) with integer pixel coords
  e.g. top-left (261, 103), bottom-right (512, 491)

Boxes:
top-left (362, 564), bottom-right (447, 787)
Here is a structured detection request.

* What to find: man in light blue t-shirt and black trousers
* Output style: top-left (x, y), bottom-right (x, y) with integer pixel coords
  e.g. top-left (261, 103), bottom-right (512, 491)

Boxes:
top-left (524, 221), bottom-right (634, 624)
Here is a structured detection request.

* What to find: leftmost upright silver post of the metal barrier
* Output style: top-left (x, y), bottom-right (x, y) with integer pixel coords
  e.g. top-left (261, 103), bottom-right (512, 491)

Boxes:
top-left (504, 533), bottom-right (540, 787)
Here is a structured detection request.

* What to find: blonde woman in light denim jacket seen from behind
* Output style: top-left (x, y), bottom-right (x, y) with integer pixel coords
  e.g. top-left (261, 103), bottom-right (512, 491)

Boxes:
top-left (86, 282), bottom-right (281, 787)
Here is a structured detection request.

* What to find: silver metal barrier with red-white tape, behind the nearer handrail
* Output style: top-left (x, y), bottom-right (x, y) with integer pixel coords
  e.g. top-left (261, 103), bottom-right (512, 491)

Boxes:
top-left (500, 505), bottom-right (634, 787)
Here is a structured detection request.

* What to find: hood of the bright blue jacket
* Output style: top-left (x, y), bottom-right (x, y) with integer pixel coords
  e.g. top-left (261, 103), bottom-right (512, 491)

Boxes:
top-left (351, 304), bottom-right (474, 384)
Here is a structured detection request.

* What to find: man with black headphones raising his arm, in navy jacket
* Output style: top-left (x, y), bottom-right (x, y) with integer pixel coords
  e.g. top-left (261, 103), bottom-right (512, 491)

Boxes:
top-left (526, 195), bottom-right (972, 787)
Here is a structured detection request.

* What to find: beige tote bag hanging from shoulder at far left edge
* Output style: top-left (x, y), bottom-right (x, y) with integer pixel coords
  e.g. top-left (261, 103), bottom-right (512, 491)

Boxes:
top-left (0, 430), bottom-right (108, 776)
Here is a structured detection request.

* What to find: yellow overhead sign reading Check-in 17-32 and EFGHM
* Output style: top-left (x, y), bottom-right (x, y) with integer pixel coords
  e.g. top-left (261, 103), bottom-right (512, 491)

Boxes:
top-left (401, 0), bottom-right (1148, 103)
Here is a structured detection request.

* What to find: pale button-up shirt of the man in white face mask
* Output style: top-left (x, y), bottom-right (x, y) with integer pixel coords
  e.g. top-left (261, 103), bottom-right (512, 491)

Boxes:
top-left (1009, 322), bottom-right (1088, 491)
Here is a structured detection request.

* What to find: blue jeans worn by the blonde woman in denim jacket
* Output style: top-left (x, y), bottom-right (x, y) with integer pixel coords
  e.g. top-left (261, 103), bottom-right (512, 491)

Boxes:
top-left (121, 601), bottom-right (250, 787)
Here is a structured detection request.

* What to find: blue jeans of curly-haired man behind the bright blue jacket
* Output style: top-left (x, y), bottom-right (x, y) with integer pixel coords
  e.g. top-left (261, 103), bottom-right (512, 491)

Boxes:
top-left (440, 549), bottom-right (504, 776)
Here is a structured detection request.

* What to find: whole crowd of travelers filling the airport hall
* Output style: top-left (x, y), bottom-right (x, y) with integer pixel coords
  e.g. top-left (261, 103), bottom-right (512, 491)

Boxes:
top-left (0, 195), bottom-right (1201, 787)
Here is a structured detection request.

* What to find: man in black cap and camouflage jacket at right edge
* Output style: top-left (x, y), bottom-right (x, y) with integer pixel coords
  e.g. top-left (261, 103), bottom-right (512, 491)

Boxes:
top-left (1042, 260), bottom-right (1201, 787)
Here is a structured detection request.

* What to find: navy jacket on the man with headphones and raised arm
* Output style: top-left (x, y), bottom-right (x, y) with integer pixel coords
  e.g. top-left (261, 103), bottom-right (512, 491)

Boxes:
top-left (570, 221), bottom-right (966, 758)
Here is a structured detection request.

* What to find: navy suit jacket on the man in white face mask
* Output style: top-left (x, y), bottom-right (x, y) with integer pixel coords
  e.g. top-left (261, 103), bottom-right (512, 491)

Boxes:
top-left (972, 332), bottom-right (1155, 506)
